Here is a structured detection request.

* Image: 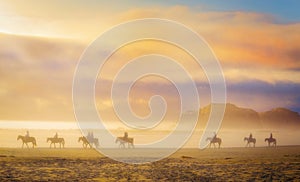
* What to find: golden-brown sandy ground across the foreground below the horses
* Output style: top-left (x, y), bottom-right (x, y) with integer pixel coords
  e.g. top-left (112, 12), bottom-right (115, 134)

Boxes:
top-left (0, 146), bottom-right (300, 181)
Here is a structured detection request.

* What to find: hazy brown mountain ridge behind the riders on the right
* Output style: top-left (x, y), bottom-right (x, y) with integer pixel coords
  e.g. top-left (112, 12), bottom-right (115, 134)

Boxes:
top-left (199, 103), bottom-right (300, 129)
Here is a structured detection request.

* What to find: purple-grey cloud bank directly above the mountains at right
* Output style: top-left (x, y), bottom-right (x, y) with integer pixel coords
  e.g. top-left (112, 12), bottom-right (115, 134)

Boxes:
top-left (227, 80), bottom-right (300, 112)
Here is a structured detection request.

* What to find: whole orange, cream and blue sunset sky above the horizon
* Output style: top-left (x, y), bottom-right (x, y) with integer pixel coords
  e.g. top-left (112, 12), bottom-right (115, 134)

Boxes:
top-left (0, 0), bottom-right (300, 121)
